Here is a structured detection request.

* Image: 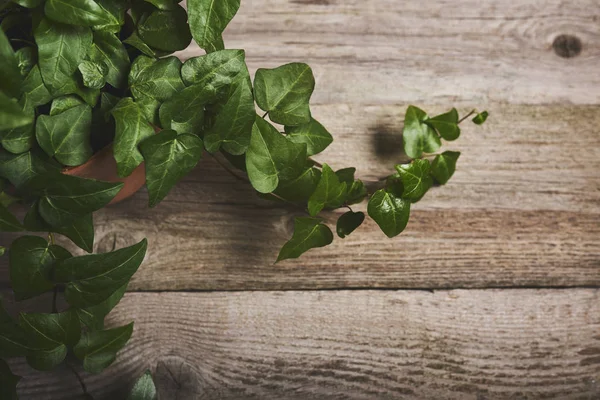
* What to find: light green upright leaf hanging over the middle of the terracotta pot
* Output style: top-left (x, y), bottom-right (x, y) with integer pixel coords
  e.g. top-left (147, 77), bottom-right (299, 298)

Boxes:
top-left (111, 97), bottom-right (154, 177)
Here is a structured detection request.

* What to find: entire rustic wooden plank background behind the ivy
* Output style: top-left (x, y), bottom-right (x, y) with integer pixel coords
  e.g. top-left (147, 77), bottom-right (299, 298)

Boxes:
top-left (0, 0), bottom-right (600, 400)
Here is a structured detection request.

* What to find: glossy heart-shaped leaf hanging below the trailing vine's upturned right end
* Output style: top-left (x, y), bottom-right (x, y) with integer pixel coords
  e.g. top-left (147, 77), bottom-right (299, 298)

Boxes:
top-left (367, 189), bottom-right (410, 238)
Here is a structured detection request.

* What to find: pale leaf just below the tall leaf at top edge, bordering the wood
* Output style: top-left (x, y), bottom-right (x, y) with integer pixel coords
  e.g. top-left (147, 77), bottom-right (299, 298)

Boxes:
top-left (181, 50), bottom-right (249, 91)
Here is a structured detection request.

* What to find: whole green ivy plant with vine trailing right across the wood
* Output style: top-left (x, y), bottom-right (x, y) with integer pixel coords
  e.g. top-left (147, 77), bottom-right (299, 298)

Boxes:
top-left (0, 0), bottom-right (488, 399)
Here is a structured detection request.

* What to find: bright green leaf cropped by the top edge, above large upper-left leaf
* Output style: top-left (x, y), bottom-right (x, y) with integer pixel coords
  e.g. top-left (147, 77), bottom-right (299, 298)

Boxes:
top-left (44, 0), bottom-right (113, 26)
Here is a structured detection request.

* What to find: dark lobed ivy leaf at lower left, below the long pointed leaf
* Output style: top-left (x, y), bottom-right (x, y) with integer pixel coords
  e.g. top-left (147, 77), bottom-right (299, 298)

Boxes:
top-left (19, 310), bottom-right (81, 371)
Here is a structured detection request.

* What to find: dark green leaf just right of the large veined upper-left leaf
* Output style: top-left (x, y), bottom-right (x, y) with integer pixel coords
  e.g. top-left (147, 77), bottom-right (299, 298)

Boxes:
top-left (90, 31), bottom-right (129, 88)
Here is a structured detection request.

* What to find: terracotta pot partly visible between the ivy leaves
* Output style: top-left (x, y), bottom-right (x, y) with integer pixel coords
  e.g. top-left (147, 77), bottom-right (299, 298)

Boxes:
top-left (62, 145), bottom-right (146, 204)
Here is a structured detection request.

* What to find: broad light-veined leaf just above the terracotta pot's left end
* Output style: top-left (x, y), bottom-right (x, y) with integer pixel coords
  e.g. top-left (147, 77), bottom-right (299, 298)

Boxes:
top-left (36, 104), bottom-right (92, 166)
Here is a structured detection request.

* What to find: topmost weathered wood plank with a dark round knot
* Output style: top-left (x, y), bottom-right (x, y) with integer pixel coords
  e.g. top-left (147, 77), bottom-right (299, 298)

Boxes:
top-left (176, 0), bottom-right (600, 104)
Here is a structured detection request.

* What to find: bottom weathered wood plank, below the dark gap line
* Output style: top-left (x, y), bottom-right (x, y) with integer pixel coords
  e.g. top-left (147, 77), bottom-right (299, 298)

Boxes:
top-left (10, 289), bottom-right (600, 400)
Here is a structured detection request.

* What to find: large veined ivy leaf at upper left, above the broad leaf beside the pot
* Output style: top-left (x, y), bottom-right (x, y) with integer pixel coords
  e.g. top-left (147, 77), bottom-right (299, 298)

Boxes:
top-left (34, 18), bottom-right (92, 97)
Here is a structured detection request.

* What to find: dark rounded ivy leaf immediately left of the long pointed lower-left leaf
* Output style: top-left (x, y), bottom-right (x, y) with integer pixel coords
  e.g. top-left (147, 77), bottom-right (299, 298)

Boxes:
top-left (9, 236), bottom-right (71, 300)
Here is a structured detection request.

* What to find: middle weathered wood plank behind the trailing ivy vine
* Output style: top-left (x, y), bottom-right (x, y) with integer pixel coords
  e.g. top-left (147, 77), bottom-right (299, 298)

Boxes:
top-left (0, 105), bottom-right (600, 290)
